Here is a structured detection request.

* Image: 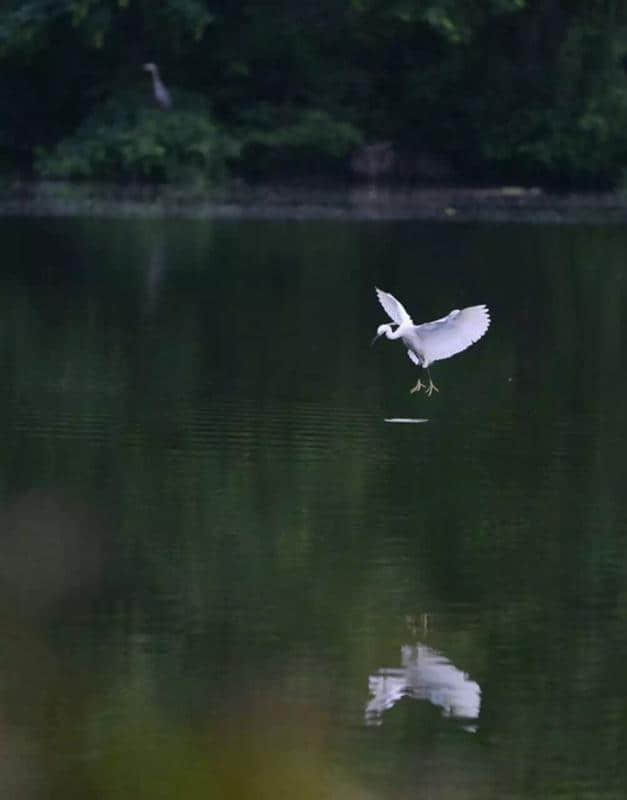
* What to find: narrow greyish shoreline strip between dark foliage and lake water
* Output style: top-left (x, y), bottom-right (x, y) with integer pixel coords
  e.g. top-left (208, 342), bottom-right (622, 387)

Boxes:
top-left (0, 181), bottom-right (627, 224)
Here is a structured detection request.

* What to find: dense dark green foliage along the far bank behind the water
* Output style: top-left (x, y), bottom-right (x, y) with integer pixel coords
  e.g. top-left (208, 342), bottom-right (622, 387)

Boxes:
top-left (0, 0), bottom-right (627, 187)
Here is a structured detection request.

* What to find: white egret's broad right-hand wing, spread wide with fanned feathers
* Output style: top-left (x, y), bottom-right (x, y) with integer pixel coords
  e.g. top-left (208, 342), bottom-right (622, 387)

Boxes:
top-left (414, 305), bottom-right (490, 363)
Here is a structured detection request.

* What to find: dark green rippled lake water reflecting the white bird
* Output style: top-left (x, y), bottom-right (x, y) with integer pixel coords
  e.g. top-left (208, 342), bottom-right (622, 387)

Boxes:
top-left (0, 219), bottom-right (627, 800)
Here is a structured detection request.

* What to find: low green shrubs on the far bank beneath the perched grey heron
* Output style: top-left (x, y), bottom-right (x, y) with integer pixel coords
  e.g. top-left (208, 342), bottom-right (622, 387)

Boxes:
top-left (35, 94), bottom-right (362, 183)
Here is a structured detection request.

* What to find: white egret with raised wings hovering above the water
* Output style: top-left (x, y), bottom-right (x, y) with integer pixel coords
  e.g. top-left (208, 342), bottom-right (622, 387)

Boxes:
top-left (372, 289), bottom-right (490, 397)
